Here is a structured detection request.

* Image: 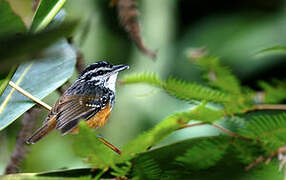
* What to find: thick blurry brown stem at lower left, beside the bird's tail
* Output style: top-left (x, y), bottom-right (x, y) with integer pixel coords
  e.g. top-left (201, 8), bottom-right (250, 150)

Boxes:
top-left (5, 107), bottom-right (38, 174)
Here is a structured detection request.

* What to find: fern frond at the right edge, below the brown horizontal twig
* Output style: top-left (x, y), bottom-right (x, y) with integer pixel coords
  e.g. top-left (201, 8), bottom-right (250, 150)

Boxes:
top-left (241, 113), bottom-right (286, 150)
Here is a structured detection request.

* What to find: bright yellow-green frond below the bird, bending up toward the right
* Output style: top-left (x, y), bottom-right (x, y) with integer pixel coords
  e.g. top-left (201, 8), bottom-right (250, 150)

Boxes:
top-left (74, 106), bottom-right (210, 168)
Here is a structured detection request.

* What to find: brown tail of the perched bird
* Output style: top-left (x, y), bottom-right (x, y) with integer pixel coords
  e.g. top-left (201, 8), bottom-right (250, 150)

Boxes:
top-left (26, 118), bottom-right (56, 144)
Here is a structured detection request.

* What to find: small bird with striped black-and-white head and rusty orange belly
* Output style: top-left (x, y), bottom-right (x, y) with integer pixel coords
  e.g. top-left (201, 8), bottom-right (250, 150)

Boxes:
top-left (26, 61), bottom-right (129, 144)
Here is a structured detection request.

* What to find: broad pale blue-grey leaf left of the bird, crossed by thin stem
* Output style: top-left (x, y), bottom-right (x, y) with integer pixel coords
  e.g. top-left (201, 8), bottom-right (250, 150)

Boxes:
top-left (0, 40), bottom-right (76, 130)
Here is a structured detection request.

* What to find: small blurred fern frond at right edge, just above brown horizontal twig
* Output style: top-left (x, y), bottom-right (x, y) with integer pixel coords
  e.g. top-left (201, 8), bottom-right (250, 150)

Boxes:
top-left (259, 81), bottom-right (286, 104)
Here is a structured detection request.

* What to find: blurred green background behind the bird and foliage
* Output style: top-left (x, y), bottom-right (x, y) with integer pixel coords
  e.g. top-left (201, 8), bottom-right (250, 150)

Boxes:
top-left (0, 0), bottom-right (286, 173)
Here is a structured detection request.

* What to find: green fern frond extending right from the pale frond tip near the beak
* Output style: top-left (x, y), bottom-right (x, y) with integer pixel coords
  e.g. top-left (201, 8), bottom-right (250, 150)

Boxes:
top-left (164, 78), bottom-right (233, 102)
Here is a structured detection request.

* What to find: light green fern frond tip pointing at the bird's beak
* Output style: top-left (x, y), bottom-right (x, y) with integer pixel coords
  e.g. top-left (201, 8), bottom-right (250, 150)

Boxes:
top-left (120, 73), bottom-right (163, 87)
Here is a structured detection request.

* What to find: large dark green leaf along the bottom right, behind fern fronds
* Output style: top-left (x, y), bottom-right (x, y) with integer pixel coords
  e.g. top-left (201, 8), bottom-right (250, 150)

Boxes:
top-left (137, 136), bottom-right (283, 180)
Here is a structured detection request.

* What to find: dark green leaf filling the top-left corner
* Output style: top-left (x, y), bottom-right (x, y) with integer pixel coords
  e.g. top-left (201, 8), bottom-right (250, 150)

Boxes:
top-left (0, 0), bottom-right (27, 37)
